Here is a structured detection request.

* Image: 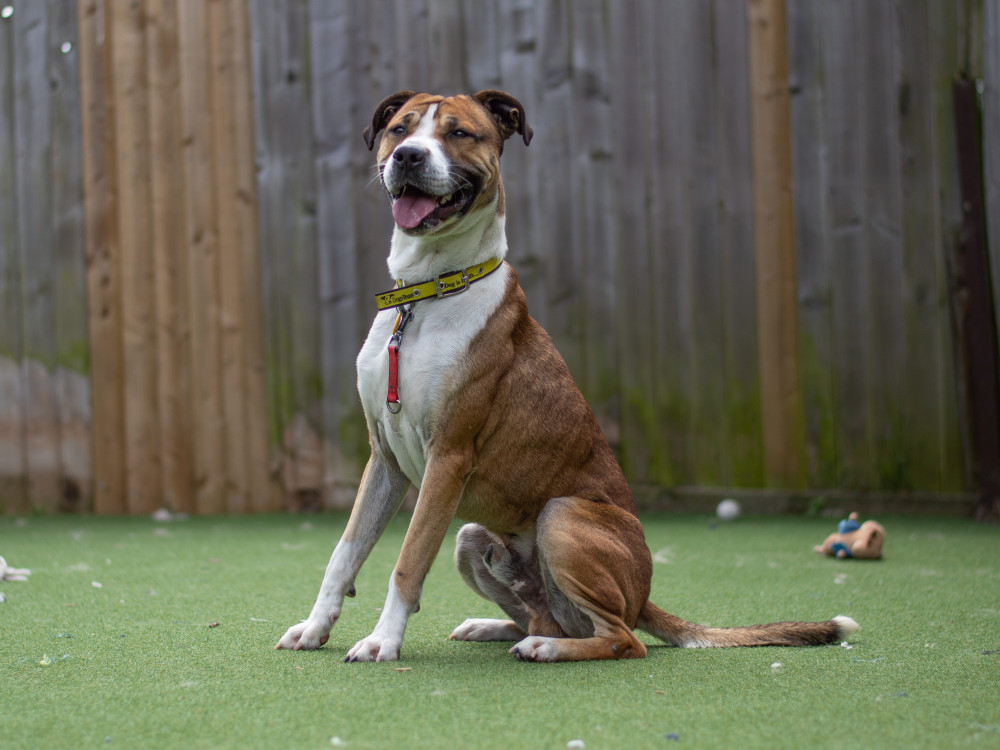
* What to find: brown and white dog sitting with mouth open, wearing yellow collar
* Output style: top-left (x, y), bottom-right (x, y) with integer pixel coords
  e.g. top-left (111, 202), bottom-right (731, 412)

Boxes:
top-left (276, 91), bottom-right (857, 662)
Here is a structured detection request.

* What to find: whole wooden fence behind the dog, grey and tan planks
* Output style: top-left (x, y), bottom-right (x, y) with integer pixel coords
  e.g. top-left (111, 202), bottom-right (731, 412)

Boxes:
top-left (0, 0), bottom-right (1000, 513)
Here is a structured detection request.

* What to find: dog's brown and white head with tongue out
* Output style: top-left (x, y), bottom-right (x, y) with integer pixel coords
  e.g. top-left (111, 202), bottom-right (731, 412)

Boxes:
top-left (364, 90), bottom-right (532, 235)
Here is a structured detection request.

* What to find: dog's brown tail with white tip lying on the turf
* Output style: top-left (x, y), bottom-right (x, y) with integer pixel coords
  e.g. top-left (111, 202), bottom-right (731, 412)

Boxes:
top-left (636, 602), bottom-right (858, 648)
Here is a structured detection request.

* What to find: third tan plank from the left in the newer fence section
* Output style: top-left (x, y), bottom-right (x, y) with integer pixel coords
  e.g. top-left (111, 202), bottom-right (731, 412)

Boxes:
top-left (146, 0), bottom-right (196, 513)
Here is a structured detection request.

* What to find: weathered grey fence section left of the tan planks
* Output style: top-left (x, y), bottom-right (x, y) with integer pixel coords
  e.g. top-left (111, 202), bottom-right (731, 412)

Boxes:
top-left (0, 3), bottom-right (92, 511)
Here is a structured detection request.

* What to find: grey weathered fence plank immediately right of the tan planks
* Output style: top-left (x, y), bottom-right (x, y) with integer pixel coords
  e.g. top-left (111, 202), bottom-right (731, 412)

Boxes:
top-left (251, 2), bottom-right (323, 504)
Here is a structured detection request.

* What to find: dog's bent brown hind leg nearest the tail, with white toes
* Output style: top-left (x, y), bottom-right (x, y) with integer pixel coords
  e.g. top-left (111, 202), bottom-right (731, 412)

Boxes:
top-left (510, 498), bottom-right (652, 661)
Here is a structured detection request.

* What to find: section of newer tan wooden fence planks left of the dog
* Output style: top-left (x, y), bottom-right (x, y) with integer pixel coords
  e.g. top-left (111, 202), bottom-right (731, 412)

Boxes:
top-left (74, 0), bottom-right (279, 513)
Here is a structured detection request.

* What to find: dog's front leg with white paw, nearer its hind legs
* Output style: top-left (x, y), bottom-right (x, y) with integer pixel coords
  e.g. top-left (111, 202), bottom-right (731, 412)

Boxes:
top-left (344, 454), bottom-right (472, 662)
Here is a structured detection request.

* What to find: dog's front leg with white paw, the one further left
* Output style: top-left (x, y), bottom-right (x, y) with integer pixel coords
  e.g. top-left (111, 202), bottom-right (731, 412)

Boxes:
top-left (275, 450), bottom-right (410, 651)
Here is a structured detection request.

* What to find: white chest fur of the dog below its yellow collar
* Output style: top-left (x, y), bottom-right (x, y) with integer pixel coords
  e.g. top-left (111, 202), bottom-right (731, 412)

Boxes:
top-left (358, 266), bottom-right (507, 487)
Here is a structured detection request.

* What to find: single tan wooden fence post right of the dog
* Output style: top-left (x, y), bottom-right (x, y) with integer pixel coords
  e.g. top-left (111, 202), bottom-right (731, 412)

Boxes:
top-left (747, 0), bottom-right (805, 487)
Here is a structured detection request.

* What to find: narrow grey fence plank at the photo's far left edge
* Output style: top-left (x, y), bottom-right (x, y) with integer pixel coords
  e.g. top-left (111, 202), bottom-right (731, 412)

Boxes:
top-left (0, 2), bottom-right (29, 513)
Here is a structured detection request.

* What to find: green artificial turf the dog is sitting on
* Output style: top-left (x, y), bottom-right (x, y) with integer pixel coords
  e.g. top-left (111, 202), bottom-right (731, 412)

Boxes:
top-left (0, 514), bottom-right (1000, 750)
